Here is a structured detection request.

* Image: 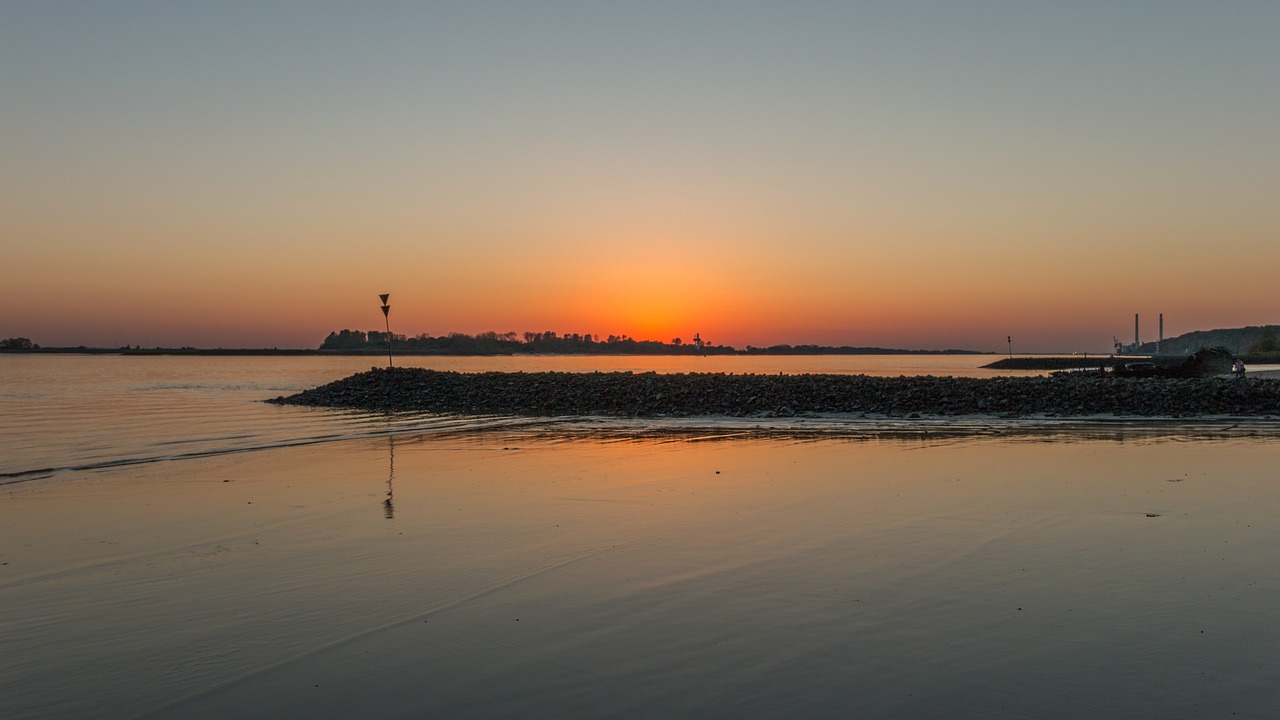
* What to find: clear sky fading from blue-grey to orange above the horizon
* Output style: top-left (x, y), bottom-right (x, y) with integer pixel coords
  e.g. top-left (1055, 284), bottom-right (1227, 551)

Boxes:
top-left (0, 0), bottom-right (1280, 352)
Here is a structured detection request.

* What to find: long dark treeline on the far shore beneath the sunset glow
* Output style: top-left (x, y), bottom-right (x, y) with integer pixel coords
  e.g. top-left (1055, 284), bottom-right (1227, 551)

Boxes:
top-left (320, 329), bottom-right (980, 355)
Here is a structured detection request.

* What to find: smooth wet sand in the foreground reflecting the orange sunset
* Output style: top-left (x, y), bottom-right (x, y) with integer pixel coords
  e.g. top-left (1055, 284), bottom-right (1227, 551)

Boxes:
top-left (0, 428), bottom-right (1280, 719)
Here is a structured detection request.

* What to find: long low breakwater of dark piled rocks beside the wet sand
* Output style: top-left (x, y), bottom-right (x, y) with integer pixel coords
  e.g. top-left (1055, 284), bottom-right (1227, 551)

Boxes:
top-left (268, 368), bottom-right (1280, 418)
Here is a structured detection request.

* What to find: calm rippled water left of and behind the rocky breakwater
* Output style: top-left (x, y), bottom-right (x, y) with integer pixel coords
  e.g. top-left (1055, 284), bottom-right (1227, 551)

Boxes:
top-left (0, 355), bottom-right (1049, 482)
